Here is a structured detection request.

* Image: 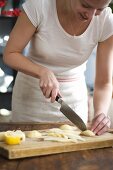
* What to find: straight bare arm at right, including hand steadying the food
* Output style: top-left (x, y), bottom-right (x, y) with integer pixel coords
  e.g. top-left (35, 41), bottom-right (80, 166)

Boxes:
top-left (92, 36), bottom-right (113, 134)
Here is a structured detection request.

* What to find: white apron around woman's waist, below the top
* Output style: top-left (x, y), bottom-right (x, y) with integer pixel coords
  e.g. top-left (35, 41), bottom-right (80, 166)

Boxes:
top-left (12, 68), bottom-right (88, 123)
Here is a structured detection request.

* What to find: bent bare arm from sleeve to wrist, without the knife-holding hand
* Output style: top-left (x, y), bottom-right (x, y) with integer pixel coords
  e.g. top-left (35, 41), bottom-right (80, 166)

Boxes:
top-left (3, 12), bottom-right (43, 77)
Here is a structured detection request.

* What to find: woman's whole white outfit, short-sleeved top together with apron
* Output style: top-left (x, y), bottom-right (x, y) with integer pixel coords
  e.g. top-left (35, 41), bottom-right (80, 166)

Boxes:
top-left (12, 0), bottom-right (113, 123)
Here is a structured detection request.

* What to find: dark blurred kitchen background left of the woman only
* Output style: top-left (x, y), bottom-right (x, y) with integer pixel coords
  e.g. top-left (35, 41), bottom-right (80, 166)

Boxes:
top-left (0, 0), bottom-right (24, 121)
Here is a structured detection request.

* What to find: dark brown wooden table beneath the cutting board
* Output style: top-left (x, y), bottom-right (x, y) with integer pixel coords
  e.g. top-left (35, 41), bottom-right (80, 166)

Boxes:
top-left (0, 123), bottom-right (113, 170)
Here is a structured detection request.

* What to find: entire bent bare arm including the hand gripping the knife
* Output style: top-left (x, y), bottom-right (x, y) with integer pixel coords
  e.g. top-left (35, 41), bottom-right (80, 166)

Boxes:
top-left (3, 12), bottom-right (60, 102)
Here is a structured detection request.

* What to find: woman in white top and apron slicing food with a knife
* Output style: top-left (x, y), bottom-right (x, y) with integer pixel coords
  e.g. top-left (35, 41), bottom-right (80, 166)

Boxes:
top-left (4, 0), bottom-right (113, 135)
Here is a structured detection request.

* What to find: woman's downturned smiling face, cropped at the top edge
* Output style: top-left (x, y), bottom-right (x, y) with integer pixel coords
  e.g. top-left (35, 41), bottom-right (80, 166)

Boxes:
top-left (70, 0), bottom-right (111, 21)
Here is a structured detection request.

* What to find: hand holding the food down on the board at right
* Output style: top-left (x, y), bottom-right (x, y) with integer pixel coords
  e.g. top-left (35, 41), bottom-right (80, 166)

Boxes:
top-left (91, 113), bottom-right (111, 135)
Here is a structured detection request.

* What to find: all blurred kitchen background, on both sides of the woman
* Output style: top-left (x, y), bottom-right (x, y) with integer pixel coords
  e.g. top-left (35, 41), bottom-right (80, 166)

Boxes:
top-left (0, 0), bottom-right (113, 122)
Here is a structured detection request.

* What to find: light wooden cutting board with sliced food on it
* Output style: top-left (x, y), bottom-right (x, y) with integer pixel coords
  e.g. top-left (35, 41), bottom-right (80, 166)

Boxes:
top-left (0, 133), bottom-right (113, 159)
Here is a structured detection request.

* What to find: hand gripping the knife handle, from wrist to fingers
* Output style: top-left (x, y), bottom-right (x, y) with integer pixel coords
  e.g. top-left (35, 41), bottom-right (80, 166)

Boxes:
top-left (39, 68), bottom-right (60, 103)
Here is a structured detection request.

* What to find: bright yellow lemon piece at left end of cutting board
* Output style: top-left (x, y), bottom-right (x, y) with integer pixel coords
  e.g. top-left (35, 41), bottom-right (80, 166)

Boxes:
top-left (5, 135), bottom-right (21, 145)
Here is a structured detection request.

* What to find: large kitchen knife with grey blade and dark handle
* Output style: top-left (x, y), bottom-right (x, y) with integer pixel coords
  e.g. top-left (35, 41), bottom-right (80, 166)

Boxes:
top-left (56, 95), bottom-right (87, 131)
